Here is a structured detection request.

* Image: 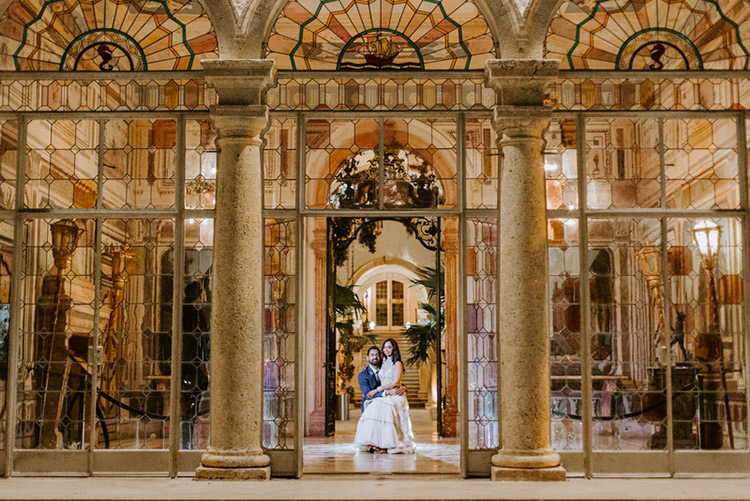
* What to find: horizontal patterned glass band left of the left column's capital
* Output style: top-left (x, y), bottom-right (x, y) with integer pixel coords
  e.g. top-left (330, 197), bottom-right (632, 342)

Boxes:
top-left (0, 80), bottom-right (217, 111)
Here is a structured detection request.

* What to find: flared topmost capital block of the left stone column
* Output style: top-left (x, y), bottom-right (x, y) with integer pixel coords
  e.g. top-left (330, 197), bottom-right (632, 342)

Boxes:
top-left (201, 59), bottom-right (276, 105)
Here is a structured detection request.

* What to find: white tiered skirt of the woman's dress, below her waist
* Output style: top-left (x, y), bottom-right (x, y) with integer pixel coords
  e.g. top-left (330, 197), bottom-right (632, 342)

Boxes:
top-left (354, 395), bottom-right (416, 454)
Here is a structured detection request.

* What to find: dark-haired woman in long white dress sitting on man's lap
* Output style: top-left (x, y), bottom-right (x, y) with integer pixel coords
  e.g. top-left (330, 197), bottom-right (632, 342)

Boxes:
top-left (354, 339), bottom-right (416, 454)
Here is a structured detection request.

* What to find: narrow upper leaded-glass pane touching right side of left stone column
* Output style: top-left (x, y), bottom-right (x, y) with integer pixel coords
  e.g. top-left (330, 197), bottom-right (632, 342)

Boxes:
top-left (263, 119), bottom-right (297, 209)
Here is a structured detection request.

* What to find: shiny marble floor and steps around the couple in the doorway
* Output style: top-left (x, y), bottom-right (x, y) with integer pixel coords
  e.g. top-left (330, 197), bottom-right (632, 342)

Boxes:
top-left (302, 409), bottom-right (460, 476)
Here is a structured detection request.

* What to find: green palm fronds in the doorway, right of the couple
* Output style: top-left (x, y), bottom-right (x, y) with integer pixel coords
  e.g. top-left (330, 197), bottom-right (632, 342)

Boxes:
top-left (404, 267), bottom-right (445, 365)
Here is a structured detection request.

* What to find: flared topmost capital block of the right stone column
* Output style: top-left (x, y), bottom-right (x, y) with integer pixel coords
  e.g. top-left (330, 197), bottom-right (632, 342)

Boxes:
top-left (484, 59), bottom-right (560, 106)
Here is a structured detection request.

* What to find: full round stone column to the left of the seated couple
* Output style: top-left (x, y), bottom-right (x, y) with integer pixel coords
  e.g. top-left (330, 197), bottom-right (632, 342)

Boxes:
top-left (195, 60), bottom-right (275, 480)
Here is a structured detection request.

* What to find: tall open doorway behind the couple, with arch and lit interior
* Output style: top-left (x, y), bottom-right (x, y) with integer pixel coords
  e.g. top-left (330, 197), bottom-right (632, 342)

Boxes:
top-left (303, 217), bottom-right (460, 475)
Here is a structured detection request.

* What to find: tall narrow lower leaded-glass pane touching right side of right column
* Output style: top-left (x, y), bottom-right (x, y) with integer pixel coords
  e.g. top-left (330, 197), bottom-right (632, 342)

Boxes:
top-left (547, 219), bottom-right (583, 450)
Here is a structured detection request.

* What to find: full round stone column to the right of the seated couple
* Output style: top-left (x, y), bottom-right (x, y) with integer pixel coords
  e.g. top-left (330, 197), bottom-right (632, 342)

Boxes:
top-left (486, 60), bottom-right (565, 481)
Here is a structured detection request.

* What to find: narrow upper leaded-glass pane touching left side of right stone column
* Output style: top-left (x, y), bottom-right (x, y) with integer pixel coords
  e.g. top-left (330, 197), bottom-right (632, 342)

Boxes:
top-left (465, 118), bottom-right (500, 209)
